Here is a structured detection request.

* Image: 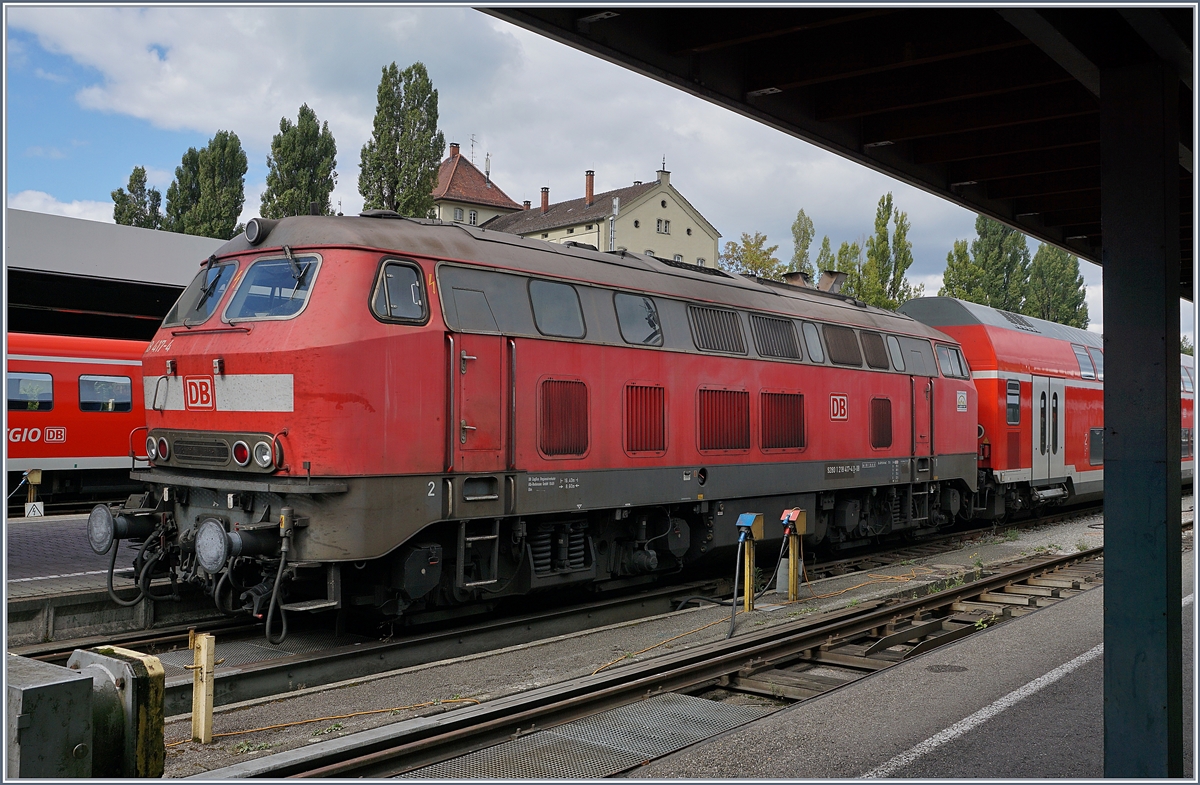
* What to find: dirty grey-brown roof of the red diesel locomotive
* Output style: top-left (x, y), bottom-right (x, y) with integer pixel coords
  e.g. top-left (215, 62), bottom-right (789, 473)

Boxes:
top-left (217, 216), bottom-right (948, 340)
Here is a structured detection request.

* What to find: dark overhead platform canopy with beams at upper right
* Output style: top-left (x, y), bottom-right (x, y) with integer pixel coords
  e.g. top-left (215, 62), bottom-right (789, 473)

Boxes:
top-left (487, 6), bottom-right (1194, 299)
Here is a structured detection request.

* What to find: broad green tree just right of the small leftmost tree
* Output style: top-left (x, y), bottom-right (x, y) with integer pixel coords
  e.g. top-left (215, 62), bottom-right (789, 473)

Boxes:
top-left (164, 131), bottom-right (246, 240)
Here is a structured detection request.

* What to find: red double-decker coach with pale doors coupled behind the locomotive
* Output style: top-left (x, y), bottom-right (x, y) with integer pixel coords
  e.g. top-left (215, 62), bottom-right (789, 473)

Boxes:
top-left (900, 298), bottom-right (1193, 517)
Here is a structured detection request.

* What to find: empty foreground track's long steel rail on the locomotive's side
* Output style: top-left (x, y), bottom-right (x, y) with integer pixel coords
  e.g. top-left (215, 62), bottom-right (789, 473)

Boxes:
top-left (211, 549), bottom-right (1103, 778)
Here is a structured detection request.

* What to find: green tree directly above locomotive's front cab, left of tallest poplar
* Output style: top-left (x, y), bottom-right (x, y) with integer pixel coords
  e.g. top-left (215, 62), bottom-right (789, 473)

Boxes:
top-left (260, 103), bottom-right (337, 218)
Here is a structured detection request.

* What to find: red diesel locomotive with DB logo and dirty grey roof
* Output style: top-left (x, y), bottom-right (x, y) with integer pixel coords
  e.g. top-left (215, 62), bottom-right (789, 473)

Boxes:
top-left (89, 211), bottom-right (978, 635)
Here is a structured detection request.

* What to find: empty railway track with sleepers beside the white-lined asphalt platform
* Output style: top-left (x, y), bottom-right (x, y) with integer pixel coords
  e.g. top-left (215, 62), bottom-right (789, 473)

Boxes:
top-left (205, 549), bottom-right (1104, 779)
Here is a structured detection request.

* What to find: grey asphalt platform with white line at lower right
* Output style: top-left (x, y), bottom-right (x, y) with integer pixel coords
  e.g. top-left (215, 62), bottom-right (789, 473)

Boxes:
top-left (629, 551), bottom-right (1195, 780)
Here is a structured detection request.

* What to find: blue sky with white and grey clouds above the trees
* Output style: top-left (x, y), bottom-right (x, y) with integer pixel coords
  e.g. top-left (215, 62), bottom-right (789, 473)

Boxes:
top-left (5, 5), bottom-right (1193, 334)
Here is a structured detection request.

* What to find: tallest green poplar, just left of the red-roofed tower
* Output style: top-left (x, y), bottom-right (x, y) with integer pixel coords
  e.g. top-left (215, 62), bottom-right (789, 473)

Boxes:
top-left (359, 62), bottom-right (445, 217)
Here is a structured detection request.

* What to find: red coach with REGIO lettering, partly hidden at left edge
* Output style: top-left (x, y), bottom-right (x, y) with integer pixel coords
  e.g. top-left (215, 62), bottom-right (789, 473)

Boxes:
top-left (6, 332), bottom-right (146, 513)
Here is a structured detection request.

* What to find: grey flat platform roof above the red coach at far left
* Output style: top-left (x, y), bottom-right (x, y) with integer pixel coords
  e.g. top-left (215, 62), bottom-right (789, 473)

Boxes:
top-left (5, 209), bottom-right (224, 340)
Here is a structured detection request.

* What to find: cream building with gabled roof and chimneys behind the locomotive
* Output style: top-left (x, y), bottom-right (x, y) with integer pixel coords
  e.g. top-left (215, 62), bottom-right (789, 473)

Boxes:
top-left (484, 169), bottom-right (721, 268)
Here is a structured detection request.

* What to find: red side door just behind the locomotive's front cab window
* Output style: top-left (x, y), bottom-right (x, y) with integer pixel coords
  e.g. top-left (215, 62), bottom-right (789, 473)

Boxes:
top-left (450, 334), bottom-right (505, 472)
